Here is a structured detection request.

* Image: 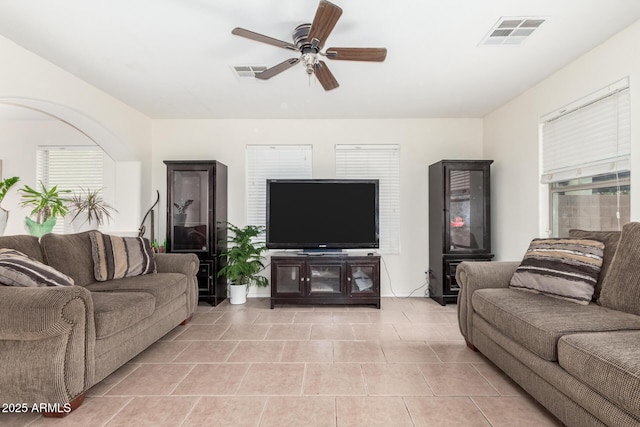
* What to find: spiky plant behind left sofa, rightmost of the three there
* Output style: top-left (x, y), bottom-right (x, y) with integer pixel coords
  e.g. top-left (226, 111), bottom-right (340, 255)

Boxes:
top-left (69, 188), bottom-right (118, 232)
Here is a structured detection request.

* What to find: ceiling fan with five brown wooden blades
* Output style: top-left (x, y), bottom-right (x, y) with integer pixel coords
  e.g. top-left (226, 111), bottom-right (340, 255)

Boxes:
top-left (231, 0), bottom-right (387, 90)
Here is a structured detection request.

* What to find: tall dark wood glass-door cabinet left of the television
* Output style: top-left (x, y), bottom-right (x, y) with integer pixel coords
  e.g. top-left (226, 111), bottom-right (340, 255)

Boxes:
top-left (164, 160), bottom-right (227, 306)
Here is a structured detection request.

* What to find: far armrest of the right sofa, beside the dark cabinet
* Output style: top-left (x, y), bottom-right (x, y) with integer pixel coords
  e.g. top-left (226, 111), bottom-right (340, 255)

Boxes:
top-left (456, 261), bottom-right (520, 344)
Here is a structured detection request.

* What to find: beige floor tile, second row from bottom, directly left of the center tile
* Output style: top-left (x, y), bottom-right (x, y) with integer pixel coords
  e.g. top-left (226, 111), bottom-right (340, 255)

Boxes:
top-left (237, 363), bottom-right (304, 396)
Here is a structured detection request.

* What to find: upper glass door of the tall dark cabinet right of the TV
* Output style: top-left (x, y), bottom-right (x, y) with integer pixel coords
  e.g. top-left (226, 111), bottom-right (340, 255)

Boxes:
top-left (447, 169), bottom-right (486, 252)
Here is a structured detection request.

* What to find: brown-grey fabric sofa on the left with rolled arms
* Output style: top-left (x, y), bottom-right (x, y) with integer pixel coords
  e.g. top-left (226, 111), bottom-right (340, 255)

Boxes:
top-left (0, 232), bottom-right (198, 416)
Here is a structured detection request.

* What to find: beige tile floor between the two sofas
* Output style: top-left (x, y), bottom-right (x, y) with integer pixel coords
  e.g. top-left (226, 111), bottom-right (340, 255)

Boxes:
top-left (0, 298), bottom-right (561, 427)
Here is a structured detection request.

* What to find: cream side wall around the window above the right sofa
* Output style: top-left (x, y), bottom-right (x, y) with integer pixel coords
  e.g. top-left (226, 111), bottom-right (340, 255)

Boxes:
top-left (483, 21), bottom-right (640, 260)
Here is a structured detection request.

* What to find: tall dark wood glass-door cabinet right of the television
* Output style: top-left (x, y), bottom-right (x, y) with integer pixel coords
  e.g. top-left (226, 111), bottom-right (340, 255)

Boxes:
top-left (429, 160), bottom-right (493, 305)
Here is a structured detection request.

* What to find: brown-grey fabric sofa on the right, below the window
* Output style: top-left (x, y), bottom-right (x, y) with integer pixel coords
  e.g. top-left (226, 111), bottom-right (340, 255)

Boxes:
top-left (456, 223), bottom-right (640, 427)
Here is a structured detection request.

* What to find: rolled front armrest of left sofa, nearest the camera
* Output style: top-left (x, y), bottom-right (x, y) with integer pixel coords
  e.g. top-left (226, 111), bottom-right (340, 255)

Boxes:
top-left (0, 286), bottom-right (95, 410)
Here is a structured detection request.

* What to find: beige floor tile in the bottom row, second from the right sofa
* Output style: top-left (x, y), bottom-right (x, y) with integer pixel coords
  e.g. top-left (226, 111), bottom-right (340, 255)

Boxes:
top-left (404, 396), bottom-right (490, 427)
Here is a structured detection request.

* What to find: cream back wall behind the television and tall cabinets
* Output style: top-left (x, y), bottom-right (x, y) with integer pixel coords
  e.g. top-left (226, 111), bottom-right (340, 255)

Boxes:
top-left (152, 119), bottom-right (482, 296)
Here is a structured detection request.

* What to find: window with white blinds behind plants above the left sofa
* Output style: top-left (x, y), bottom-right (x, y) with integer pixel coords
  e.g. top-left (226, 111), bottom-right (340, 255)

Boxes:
top-left (36, 146), bottom-right (104, 233)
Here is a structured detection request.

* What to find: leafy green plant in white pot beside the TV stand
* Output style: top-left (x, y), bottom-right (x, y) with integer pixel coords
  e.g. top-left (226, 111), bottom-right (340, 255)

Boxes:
top-left (218, 223), bottom-right (269, 304)
